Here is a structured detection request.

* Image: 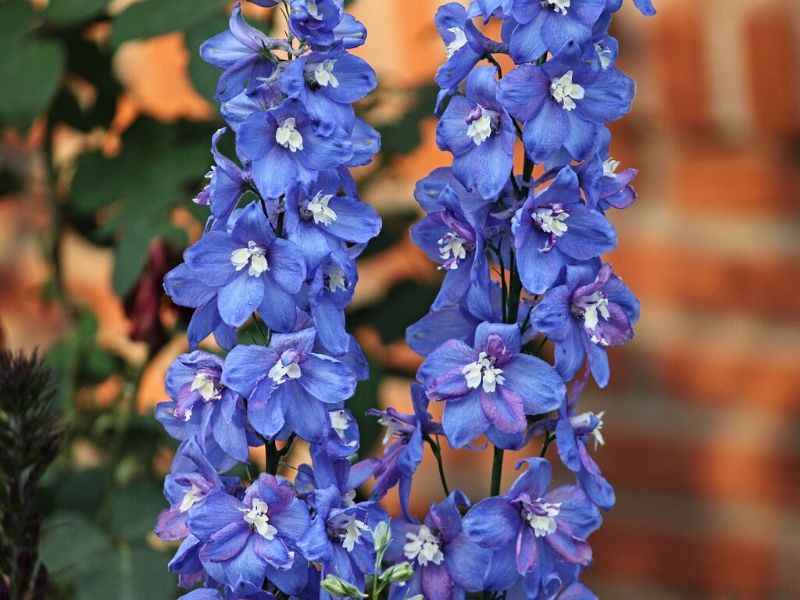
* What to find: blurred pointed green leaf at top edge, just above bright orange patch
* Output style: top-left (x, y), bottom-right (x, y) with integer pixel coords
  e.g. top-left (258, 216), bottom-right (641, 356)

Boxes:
top-left (111, 0), bottom-right (225, 47)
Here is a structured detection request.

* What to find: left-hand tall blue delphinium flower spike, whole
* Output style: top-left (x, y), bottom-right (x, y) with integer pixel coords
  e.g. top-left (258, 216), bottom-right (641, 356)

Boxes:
top-left (156, 0), bottom-right (388, 600)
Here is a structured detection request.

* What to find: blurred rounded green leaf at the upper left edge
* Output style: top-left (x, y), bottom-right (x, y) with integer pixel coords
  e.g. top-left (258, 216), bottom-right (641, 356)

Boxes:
top-left (0, 41), bottom-right (64, 130)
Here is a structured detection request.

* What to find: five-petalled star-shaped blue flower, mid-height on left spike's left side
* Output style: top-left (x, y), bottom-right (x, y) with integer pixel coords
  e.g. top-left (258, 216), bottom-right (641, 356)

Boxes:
top-left (184, 202), bottom-right (306, 331)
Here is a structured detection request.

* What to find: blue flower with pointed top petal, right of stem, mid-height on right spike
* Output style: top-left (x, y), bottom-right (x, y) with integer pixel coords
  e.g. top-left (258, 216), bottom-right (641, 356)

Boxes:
top-left (512, 167), bottom-right (617, 294)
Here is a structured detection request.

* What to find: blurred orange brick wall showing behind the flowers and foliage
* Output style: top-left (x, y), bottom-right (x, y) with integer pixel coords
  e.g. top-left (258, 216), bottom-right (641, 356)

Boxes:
top-left (0, 0), bottom-right (800, 600)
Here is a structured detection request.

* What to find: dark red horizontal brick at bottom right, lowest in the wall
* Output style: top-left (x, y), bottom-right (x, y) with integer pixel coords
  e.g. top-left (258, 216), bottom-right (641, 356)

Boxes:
top-left (585, 513), bottom-right (777, 600)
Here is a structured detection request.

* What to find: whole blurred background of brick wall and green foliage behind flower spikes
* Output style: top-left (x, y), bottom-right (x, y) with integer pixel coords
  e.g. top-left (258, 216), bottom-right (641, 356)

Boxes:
top-left (0, 0), bottom-right (800, 600)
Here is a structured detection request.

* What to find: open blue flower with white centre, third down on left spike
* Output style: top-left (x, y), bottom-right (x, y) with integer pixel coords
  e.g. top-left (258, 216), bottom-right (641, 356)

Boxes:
top-left (236, 99), bottom-right (353, 198)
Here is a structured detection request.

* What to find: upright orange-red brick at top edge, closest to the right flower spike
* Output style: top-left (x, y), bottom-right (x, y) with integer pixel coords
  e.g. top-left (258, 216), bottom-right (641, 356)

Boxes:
top-left (648, 0), bottom-right (712, 129)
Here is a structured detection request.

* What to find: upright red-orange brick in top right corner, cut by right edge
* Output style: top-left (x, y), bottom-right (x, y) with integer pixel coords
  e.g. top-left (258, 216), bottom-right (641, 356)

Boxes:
top-left (744, 0), bottom-right (800, 136)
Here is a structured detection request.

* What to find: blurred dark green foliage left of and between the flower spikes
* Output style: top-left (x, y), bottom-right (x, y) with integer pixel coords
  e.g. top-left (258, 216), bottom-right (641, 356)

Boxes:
top-left (0, 0), bottom-right (436, 600)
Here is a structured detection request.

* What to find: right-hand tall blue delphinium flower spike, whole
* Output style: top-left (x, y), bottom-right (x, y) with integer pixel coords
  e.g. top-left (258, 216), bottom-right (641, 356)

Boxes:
top-left (366, 0), bottom-right (655, 600)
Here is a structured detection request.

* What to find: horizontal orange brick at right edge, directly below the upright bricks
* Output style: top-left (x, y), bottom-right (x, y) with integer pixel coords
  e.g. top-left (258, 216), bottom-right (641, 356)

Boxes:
top-left (672, 143), bottom-right (800, 216)
